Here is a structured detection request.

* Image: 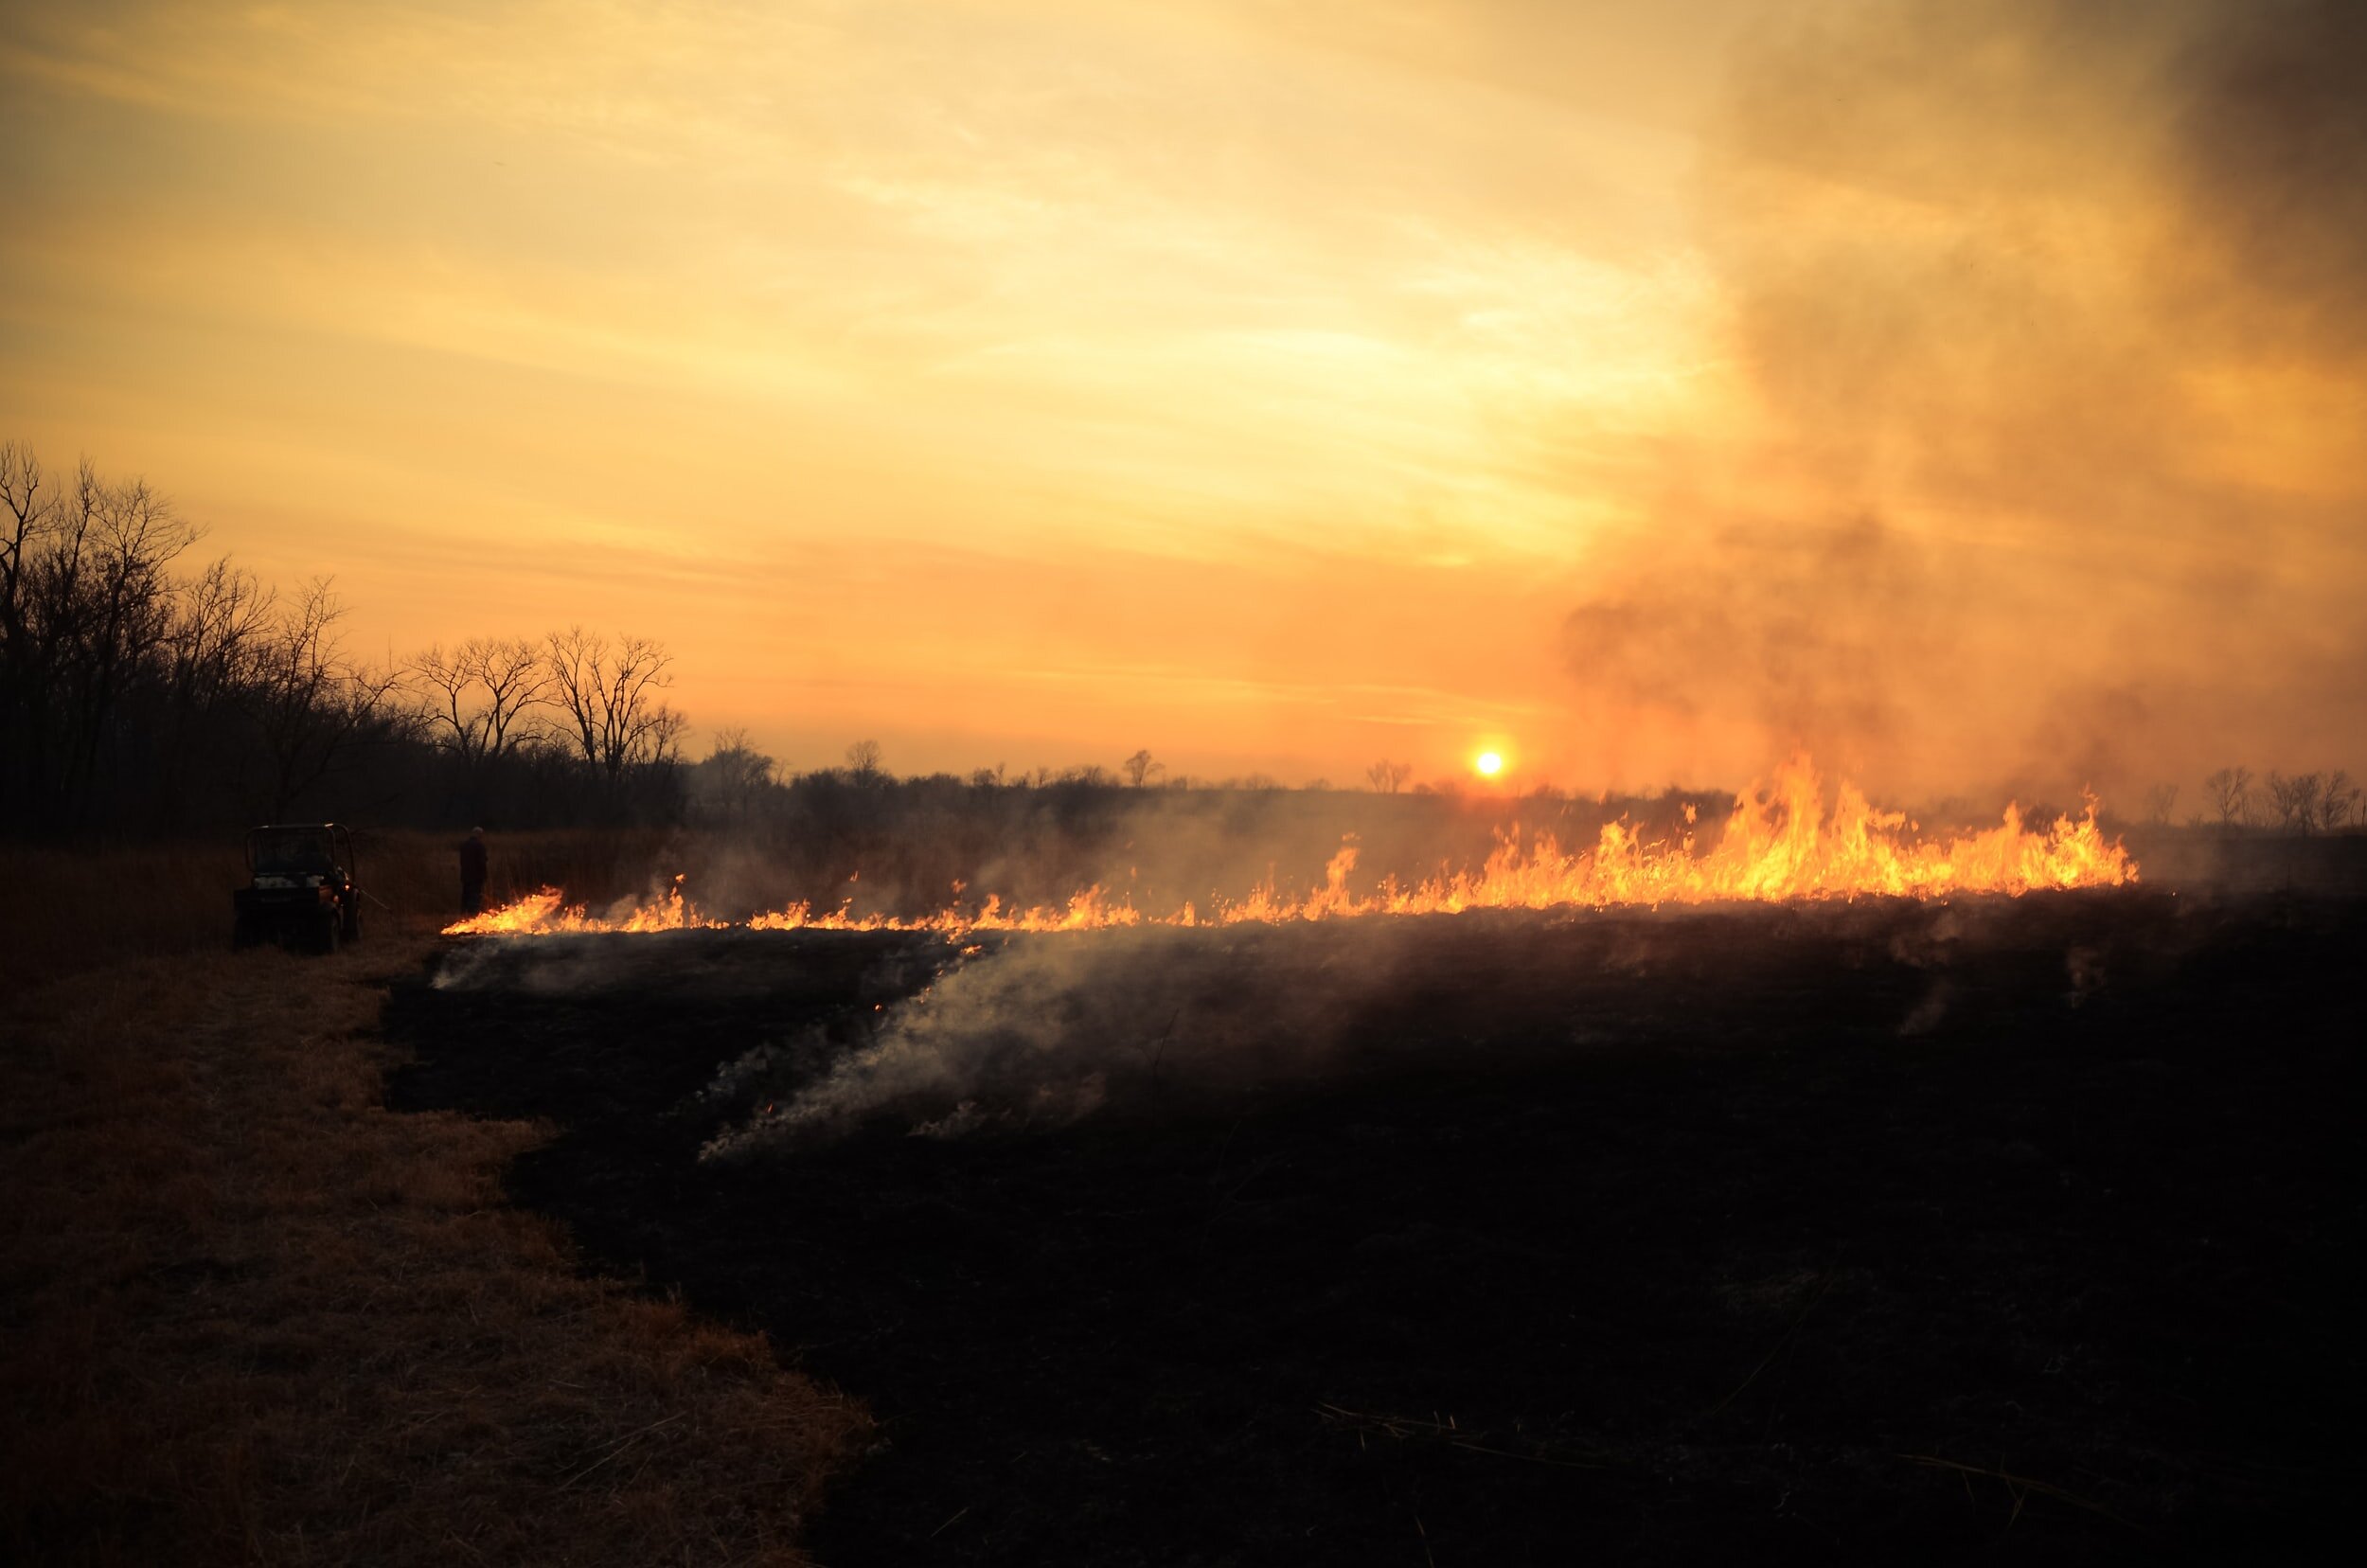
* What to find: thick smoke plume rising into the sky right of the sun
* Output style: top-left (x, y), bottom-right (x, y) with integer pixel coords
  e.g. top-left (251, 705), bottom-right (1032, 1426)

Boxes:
top-left (1567, 0), bottom-right (2367, 798)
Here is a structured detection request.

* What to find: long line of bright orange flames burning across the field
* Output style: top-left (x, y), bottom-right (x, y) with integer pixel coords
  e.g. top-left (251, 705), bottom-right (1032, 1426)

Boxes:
top-left (445, 757), bottom-right (2138, 935)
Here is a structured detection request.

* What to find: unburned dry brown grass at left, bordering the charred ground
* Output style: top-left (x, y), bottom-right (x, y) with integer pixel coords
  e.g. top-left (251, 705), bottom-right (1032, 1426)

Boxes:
top-left (0, 846), bottom-right (869, 1563)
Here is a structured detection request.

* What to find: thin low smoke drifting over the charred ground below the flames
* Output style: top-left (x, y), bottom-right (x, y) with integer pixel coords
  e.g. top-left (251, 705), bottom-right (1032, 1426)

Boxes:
top-left (699, 893), bottom-right (2192, 1161)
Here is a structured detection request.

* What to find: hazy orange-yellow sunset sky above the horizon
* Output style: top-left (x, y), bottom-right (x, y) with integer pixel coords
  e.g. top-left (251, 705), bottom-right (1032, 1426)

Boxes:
top-left (0, 0), bottom-right (2367, 787)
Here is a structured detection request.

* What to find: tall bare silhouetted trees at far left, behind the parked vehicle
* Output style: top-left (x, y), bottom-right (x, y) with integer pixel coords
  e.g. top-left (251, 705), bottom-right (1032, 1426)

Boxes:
top-left (0, 443), bottom-right (685, 839)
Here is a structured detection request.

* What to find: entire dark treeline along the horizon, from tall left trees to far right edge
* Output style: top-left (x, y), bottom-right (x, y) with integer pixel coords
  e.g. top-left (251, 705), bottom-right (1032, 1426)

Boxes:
top-left (13, 443), bottom-right (2367, 855)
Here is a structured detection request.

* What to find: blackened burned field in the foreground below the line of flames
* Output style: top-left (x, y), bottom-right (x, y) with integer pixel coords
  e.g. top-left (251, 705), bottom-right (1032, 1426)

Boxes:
top-left (388, 893), bottom-right (2367, 1565)
